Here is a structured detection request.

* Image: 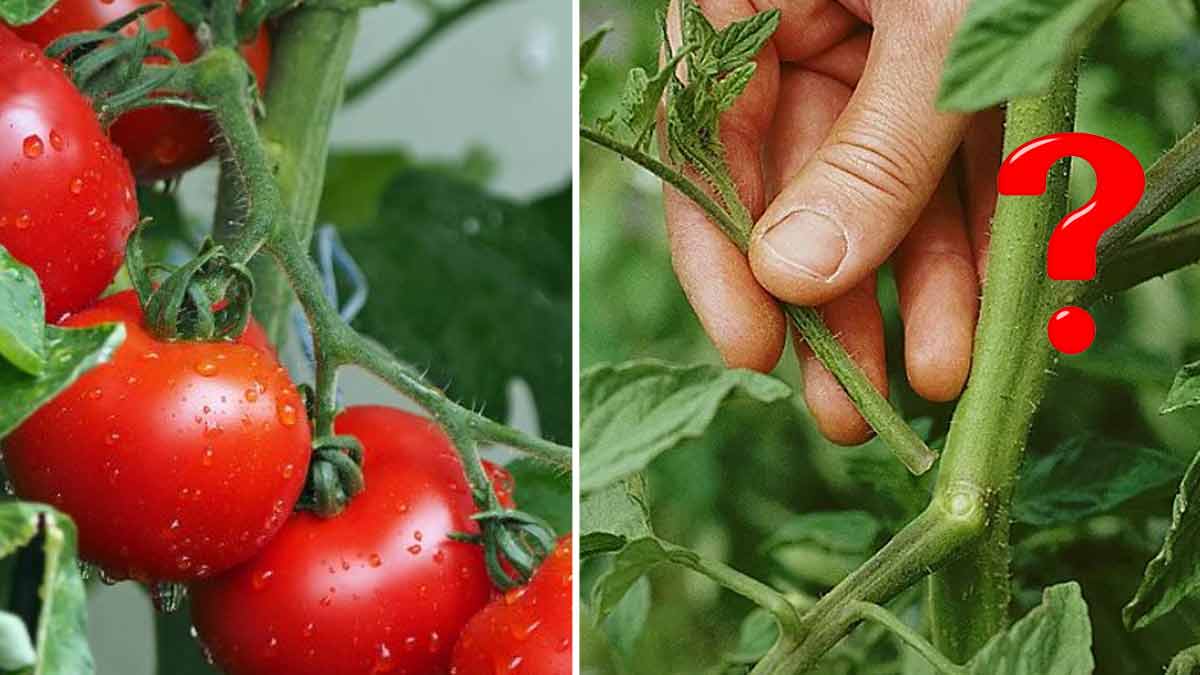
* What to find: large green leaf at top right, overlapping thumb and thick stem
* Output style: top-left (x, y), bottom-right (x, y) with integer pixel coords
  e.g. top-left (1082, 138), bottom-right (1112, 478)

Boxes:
top-left (937, 0), bottom-right (1121, 110)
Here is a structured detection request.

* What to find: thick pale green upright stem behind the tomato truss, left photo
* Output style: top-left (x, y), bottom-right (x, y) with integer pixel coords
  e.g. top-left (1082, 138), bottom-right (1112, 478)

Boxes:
top-left (216, 7), bottom-right (358, 342)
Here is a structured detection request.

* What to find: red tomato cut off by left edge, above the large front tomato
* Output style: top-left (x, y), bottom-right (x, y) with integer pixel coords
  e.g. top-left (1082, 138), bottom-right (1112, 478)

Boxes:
top-left (0, 26), bottom-right (138, 321)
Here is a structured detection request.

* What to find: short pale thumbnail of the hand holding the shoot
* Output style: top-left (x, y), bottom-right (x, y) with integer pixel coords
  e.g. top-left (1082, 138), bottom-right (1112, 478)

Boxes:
top-left (762, 211), bottom-right (846, 281)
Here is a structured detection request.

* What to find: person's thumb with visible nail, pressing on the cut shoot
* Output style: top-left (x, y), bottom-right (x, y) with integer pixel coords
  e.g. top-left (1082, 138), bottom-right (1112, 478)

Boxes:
top-left (750, 1), bottom-right (968, 305)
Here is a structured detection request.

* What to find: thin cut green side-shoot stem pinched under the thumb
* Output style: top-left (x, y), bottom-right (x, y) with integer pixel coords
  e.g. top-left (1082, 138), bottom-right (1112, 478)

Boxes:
top-left (580, 126), bottom-right (937, 474)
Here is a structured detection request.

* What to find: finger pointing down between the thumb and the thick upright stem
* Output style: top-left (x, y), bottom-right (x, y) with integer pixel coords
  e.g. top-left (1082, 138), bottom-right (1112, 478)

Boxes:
top-left (893, 170), bottom-right (979, 401)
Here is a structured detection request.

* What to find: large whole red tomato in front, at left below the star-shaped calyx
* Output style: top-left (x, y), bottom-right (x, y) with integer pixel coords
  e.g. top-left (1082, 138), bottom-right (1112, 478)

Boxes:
top-left (4, 291), bottom-right (311, 581)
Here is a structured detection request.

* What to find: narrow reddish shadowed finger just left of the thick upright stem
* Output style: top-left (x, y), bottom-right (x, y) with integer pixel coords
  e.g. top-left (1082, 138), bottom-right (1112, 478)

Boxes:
top-left (959, 108), bottom-right (1004, 281)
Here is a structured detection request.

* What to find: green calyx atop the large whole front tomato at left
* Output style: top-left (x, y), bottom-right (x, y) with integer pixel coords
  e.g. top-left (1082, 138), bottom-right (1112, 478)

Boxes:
top-left (126, 227), bottom-right (254, 341)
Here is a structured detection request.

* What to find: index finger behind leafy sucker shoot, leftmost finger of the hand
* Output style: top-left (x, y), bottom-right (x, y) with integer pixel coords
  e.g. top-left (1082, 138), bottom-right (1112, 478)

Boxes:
top-left (659, 1), bottom-right (787, 371)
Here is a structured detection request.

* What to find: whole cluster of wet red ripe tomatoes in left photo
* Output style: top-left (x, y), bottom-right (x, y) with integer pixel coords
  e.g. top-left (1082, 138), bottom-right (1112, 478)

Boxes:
top-left (0, 0), bottom-right (571, 675)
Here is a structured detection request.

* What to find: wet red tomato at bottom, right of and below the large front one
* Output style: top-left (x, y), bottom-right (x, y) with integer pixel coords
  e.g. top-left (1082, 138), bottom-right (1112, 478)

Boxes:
top-left (191, 406), bottom-right (506, 675)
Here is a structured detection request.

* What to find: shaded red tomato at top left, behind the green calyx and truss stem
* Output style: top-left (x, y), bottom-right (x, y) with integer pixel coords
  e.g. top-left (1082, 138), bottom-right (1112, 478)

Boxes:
top-left (13, 0), bottom-right (271, 180)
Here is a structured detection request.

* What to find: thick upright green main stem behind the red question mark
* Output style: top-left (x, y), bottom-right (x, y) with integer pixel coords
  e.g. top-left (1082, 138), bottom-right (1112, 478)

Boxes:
top-left (930, 61), bottom-right (1075, 663)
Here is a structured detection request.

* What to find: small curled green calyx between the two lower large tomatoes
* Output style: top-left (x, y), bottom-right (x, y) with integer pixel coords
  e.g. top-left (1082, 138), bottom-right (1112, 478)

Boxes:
top-left (296, 436), bottom-right (366, 518)
